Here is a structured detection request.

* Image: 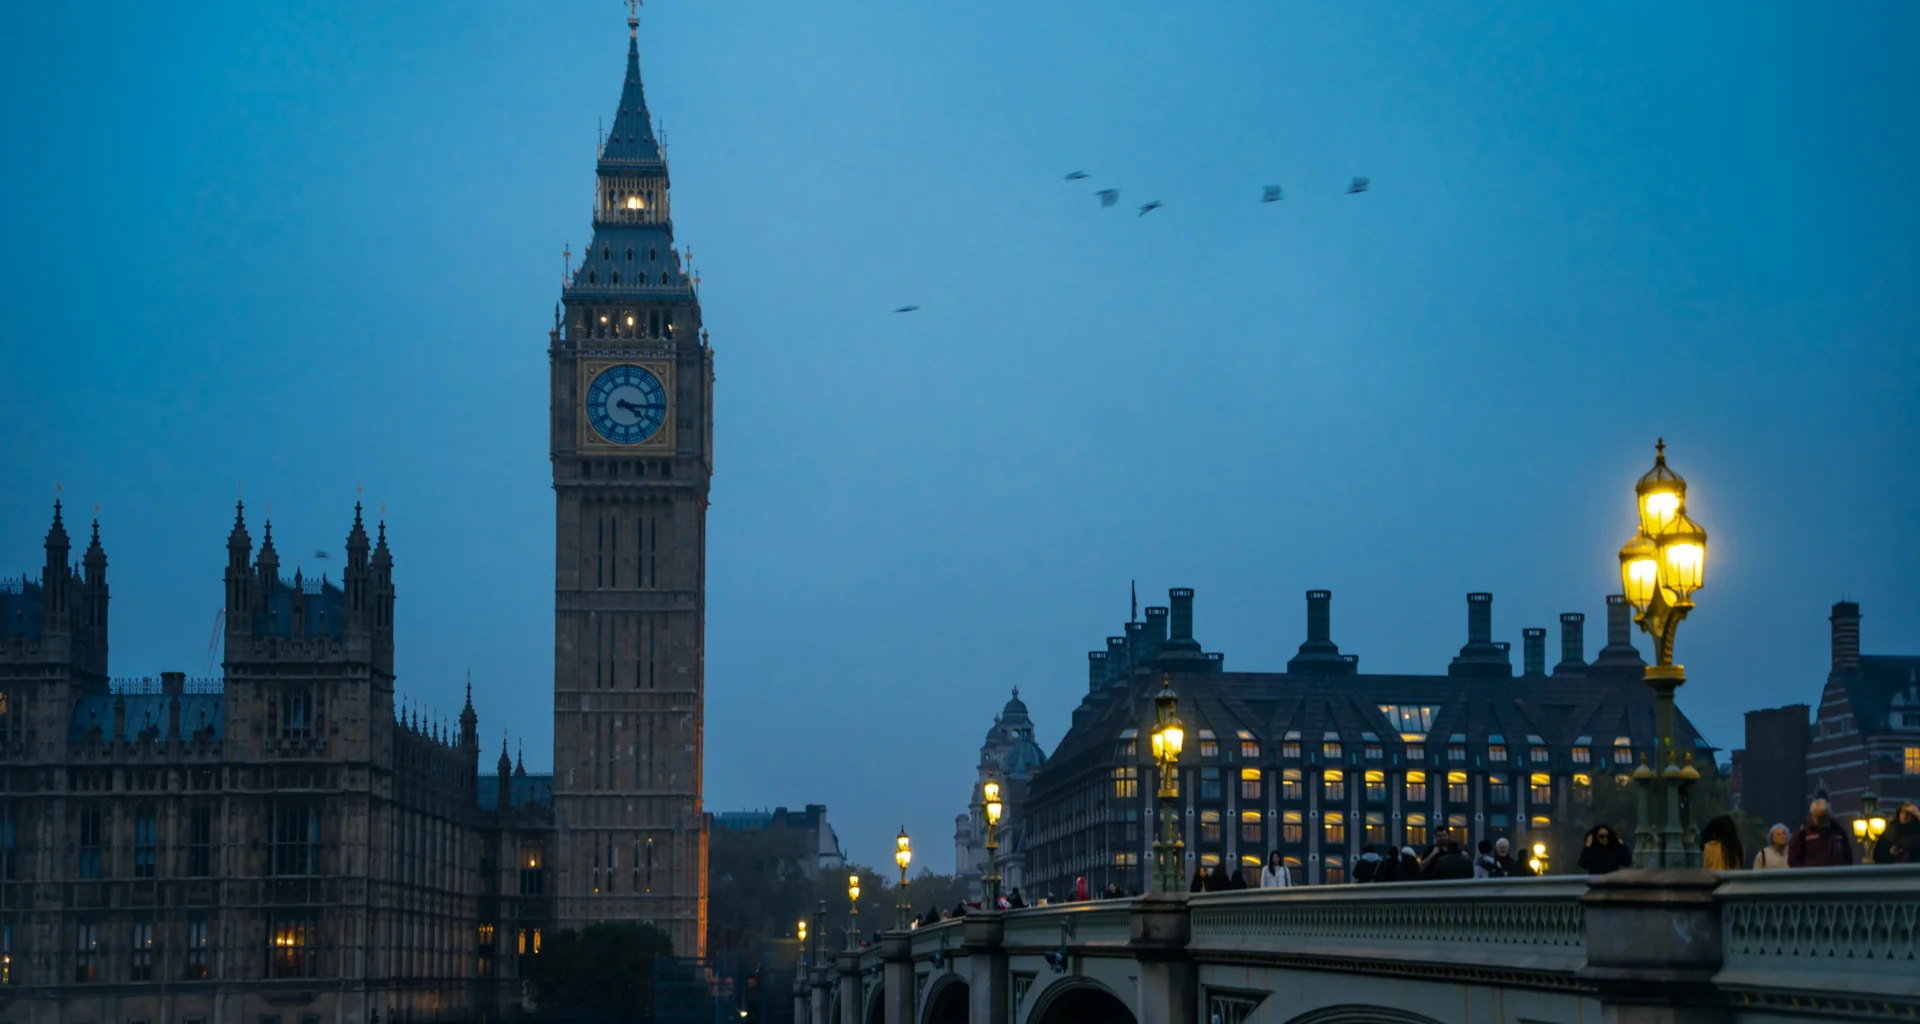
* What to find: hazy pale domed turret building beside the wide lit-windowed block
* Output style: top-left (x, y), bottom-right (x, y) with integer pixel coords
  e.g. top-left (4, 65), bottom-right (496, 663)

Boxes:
top-left (954, 686), bottom-right (1046, 899)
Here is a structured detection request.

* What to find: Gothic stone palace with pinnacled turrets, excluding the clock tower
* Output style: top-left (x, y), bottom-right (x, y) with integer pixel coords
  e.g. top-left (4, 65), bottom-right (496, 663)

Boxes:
top-left (0, 503), bottom-right (553, 1024)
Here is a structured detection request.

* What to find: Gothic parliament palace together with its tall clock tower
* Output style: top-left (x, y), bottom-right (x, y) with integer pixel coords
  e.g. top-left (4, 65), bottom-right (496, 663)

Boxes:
top-left (0, 9), bottom-right (712, 1024)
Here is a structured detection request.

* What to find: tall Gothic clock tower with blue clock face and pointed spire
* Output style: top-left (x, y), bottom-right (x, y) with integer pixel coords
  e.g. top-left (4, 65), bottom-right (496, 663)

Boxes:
top-left (549, 3), bottom-right (714, 957)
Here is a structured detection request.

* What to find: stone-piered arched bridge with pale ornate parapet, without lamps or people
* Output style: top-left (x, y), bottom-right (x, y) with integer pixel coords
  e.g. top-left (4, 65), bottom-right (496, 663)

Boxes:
top-left (793, 865), bottom-right (1920, 1024)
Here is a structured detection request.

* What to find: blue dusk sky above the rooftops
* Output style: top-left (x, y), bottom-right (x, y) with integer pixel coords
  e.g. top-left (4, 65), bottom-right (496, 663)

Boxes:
top-left (0, 0), bottom-right (1920, 870)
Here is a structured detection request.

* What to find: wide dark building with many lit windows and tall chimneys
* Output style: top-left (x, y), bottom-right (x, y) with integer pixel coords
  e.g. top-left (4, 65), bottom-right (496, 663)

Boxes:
top-left (1021, 588), bottom-right (1718, 895)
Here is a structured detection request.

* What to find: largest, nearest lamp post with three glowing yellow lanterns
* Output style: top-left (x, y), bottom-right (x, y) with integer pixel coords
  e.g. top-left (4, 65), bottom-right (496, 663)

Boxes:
top-left (1620, 438), bottom-right (1707, 868)
